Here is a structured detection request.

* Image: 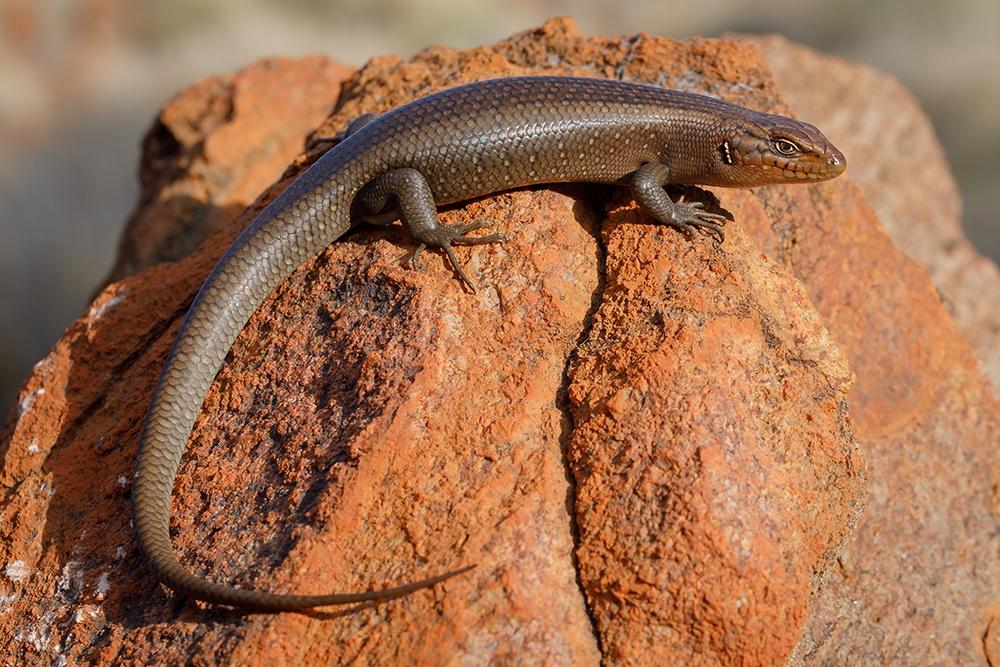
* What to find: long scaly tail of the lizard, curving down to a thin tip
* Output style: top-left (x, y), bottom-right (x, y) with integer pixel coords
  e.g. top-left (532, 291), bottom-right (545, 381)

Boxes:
top-left (132, 176), bottom-right (469, 611)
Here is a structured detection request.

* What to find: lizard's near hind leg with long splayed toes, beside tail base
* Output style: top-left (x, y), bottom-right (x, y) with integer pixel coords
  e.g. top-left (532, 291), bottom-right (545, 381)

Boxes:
top-left (355, 168), bottom-right (507, 292)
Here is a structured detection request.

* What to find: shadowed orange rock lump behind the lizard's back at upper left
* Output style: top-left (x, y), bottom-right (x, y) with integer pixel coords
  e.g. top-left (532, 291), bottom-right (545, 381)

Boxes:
top-left (107, 56), bottom-right (351, 282)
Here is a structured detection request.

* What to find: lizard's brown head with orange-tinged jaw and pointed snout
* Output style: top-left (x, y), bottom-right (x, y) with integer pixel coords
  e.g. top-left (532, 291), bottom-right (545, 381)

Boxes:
top-left (718, 113), bottom-right (847, 187)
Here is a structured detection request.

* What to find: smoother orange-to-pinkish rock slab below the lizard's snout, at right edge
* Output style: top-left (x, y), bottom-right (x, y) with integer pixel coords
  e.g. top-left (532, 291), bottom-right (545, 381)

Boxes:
top-left (722, 180), bottom-right (1000, 665)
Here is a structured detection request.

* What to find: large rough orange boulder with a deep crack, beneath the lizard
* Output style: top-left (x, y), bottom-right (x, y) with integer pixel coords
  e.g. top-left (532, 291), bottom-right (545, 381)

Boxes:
top-left (0, 21), bottom-right (1000, 665)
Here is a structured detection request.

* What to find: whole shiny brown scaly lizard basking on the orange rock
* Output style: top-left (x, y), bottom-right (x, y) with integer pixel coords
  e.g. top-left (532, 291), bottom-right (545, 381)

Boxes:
top-left (132, 76), bottom-right (847, 611)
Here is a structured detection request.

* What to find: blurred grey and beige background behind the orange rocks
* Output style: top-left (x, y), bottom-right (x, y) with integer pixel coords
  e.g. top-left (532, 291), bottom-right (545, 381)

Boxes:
top-left (0, 0), bottom-right (1000, 414)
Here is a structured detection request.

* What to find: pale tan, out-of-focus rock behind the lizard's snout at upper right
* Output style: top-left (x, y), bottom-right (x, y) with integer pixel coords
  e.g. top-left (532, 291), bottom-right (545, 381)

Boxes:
top-left (754, 36), bottom-right (1000, 388)
